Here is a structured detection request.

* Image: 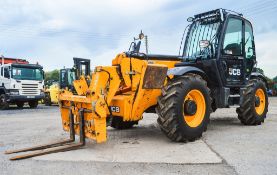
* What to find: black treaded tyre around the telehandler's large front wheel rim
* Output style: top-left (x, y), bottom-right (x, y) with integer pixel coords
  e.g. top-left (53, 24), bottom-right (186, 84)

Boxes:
top-left (156, 74), bottom-right (211, 142)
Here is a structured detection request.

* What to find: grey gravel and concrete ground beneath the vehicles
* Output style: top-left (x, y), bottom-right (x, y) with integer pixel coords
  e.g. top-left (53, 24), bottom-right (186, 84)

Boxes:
top-left (0, 98), bottom-right (277, 175)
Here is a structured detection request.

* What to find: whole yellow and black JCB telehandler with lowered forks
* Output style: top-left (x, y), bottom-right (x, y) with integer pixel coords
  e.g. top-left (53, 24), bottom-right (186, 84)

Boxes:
top-left (6, 9), bottom-right (268, 160)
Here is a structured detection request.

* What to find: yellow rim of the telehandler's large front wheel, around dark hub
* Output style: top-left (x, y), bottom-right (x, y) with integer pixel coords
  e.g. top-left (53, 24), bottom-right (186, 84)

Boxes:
top-left (183, 90), bottom-right (206, 127)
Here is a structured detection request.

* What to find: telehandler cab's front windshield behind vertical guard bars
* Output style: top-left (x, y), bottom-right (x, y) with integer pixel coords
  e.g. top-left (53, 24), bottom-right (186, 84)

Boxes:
top-left (184, 19), bottom-right (220, 60)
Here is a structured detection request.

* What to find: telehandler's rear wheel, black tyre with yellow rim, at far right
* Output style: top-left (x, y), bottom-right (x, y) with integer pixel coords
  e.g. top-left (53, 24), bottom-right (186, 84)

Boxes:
top-left (237, 79), bottom-right (268, 125)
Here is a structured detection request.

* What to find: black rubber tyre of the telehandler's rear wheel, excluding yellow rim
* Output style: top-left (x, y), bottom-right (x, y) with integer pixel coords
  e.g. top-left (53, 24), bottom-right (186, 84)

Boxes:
top-left (236, 79), bottom-right (268, 125)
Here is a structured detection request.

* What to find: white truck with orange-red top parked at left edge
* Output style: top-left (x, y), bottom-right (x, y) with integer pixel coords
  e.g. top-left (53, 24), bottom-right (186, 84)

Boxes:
top-left (0, 56), bottom-right (44, 110)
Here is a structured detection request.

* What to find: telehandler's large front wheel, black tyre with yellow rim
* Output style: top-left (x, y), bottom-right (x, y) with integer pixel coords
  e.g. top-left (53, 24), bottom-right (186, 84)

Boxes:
top-left (156, 74), bottom-right (211, 142)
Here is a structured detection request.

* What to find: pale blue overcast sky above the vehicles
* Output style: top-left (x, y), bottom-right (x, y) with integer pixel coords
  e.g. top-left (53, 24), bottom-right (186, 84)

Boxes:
top-left (0, 0), bottom-right (277, 78)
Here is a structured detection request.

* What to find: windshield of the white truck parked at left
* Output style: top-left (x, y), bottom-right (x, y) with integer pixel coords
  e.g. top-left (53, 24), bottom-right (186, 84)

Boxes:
top-left (12, 67), bottom-right (43, 81)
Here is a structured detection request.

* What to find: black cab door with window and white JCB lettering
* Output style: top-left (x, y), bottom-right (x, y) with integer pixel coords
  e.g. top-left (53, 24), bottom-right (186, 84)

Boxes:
top-left (219, 16), bottom-right (245, 86)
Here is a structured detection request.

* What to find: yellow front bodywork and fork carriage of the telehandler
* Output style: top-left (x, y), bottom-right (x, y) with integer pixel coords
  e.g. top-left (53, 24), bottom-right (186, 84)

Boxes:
top-left (59, 53), bottom-right (178, 143)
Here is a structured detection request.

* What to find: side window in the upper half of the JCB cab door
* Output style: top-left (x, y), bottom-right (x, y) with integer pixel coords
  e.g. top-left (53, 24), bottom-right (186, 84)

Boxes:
top-left (223, 18), bottom-right (242, 56)
